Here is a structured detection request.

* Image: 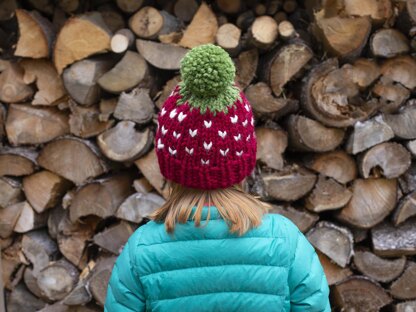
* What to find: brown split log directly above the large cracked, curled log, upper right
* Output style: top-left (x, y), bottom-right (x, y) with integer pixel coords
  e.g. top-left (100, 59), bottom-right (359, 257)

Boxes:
top-left (314, 10), bottom-right (371, 60)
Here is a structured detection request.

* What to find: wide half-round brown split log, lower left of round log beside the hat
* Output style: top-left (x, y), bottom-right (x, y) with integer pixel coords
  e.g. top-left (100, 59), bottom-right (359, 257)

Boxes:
top-left (37, 137), bottom-right (108, 185)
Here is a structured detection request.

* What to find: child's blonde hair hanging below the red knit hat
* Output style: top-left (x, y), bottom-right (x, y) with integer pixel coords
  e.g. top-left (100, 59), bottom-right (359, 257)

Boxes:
top-left (148, 181), bottom-right (270, 236)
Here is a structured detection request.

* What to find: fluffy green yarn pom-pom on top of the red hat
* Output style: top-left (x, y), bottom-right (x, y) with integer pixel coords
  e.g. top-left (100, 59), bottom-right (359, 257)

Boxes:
top-left (177, 44), bottom-right (240, 114)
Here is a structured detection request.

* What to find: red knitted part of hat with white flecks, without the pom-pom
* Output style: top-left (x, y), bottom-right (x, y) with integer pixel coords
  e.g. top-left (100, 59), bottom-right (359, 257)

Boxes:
top-left (155, 86), bottom-right (257, 190)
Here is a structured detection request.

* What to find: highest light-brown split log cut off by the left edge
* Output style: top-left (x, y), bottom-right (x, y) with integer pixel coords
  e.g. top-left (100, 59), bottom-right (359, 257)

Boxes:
top-left (0, 60), bottom-right (34, 103)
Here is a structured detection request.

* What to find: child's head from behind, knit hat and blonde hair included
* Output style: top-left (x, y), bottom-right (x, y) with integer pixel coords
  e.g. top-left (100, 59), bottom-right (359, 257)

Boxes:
top-left (154, 44), bottom-right (264, 232)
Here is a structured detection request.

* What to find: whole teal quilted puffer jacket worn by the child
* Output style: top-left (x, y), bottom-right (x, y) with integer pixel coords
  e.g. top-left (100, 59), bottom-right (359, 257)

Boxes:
top-left (104, 207), bottom-right (331, 312)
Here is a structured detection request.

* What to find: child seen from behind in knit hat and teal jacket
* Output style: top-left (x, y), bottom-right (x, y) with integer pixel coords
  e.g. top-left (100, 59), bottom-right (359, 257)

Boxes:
top-left (105, 44), bottom-right (331, 312)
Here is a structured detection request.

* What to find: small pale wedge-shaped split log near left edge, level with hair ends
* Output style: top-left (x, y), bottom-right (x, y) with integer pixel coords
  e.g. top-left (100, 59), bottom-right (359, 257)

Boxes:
top-left (13, 201), bottom-right (48, 233)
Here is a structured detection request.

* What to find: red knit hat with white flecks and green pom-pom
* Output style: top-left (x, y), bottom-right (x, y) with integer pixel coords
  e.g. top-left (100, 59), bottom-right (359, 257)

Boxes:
top-left (155, 44), bottom-right (257, 190)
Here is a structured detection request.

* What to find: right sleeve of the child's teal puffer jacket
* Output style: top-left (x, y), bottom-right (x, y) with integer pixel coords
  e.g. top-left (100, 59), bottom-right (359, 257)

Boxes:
top-left (288, 224), bottom-right (331, 312)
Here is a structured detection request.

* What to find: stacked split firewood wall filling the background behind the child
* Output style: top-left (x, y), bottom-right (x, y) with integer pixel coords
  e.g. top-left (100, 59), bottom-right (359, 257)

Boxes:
top-left (0, 0), bottom-right (416, 312)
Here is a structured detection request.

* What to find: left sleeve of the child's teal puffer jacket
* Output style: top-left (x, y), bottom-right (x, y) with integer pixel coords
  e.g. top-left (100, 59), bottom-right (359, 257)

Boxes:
top-left (104, 231), bottom-right (146, 312)
